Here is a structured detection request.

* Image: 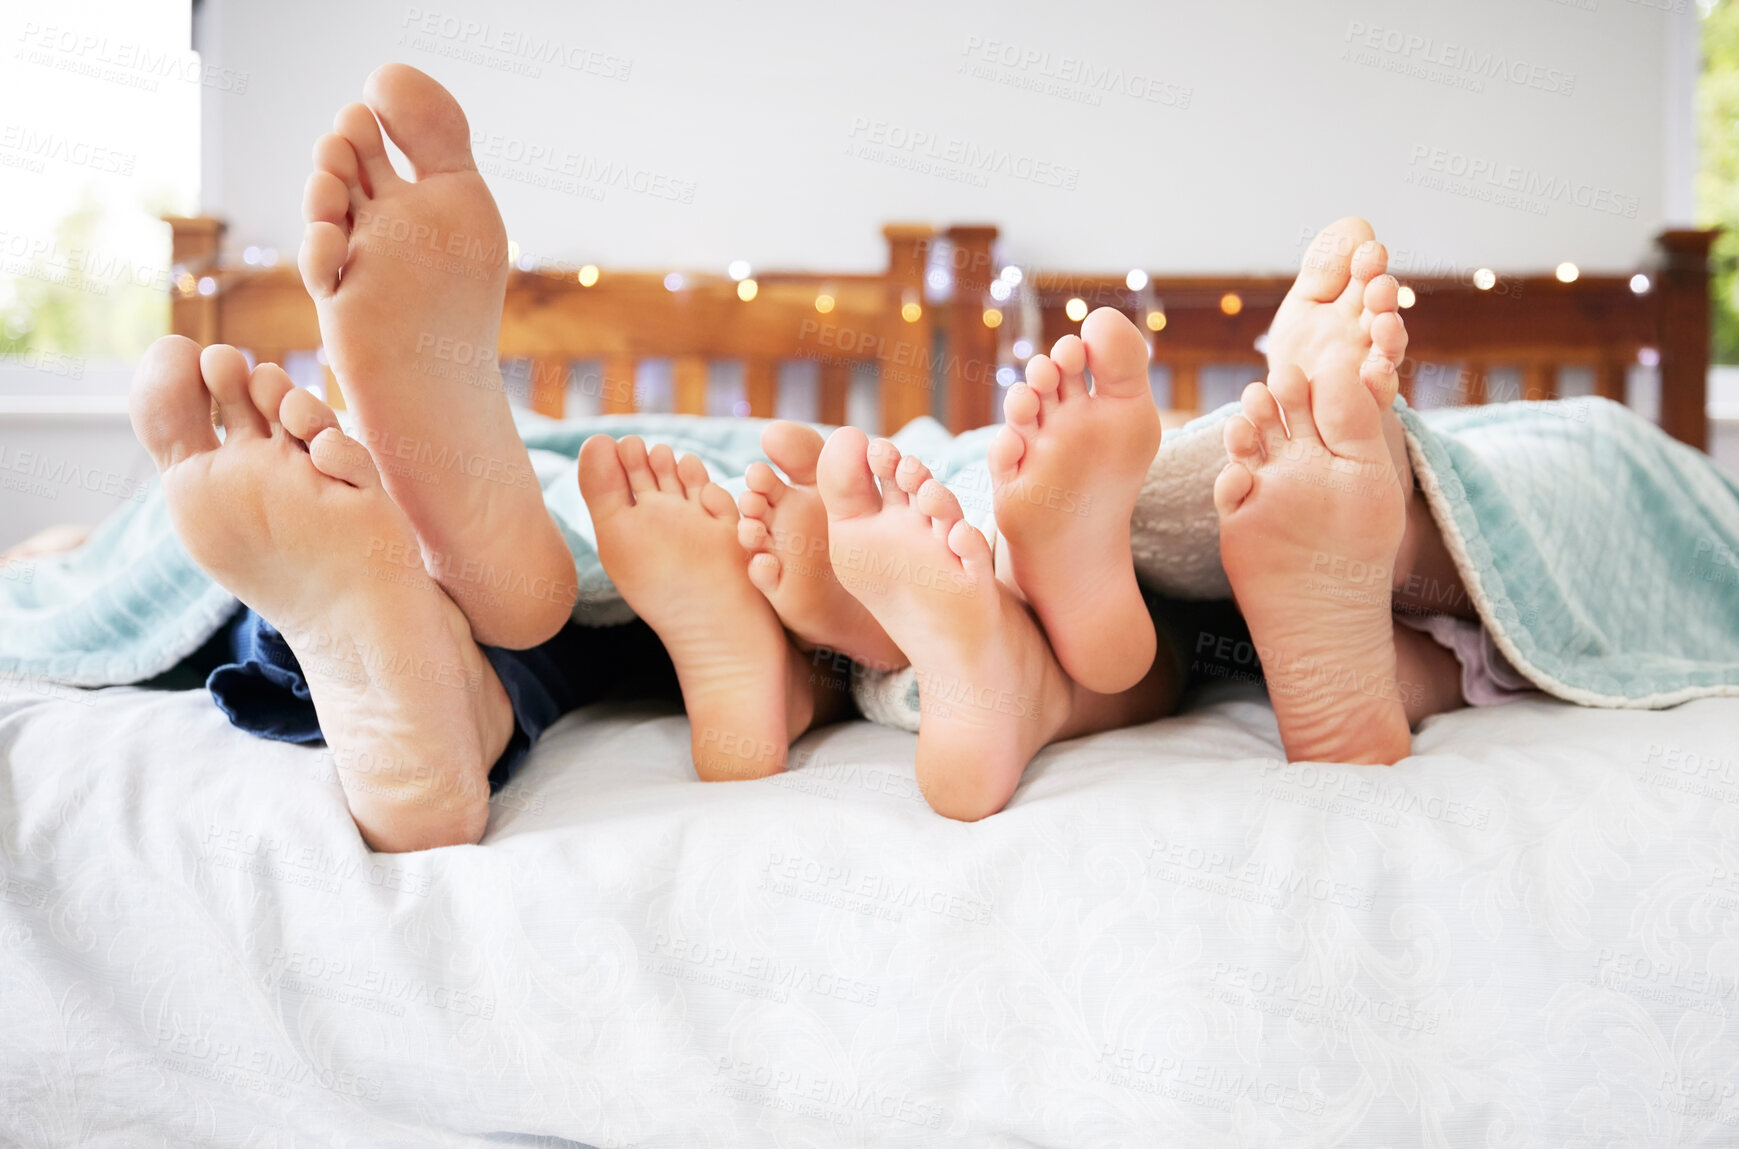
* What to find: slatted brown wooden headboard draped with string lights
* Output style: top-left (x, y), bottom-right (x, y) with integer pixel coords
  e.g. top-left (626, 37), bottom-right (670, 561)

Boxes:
top-left (169, 217), bottom-right (1715, 448)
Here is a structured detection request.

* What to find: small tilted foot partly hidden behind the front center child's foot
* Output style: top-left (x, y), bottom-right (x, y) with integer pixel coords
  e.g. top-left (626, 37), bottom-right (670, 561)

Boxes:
top-left (737, 421), bottom-right (906, 669)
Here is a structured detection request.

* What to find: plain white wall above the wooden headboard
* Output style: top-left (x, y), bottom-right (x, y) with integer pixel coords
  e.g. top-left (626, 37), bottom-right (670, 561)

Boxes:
top-left (197, 0), bottom-right (1696, 271)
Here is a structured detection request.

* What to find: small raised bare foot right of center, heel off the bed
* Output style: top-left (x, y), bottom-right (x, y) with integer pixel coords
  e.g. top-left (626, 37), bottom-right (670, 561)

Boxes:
top-left (989, 308), bottom-right (1160, 694)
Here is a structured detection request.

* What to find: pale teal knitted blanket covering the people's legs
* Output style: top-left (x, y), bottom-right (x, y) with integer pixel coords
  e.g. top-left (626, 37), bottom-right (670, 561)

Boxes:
top-left (0, 400), bottom-right (1739, 707)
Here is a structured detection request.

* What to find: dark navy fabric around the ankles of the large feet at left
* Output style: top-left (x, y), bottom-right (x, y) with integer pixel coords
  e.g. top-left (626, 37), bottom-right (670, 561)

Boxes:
top-left (205, 608), bottom-right (680, 793)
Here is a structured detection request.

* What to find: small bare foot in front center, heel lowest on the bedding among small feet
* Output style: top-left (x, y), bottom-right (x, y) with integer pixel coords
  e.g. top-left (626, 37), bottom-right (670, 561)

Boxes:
top-left (817, 428), bottom-right (1071, 820)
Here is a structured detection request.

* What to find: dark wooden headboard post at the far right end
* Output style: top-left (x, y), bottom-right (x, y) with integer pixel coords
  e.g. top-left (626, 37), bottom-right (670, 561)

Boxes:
top-left (1656, 228), bottom-right (1720, 450)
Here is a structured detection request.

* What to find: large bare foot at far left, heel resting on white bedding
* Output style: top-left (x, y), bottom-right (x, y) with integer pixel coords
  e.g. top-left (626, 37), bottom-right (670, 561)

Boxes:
top-left (130, 335), bottom-right (513, 852)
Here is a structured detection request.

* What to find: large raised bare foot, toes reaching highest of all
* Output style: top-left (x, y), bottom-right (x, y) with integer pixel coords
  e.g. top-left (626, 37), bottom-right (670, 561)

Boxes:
top-left (301, 64), bottom-right (579, 648)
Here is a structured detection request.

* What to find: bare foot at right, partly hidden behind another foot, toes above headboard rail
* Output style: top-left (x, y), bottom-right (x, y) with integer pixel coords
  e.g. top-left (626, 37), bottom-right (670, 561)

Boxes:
top-left (1268, 217), bottom-right (1407, 410)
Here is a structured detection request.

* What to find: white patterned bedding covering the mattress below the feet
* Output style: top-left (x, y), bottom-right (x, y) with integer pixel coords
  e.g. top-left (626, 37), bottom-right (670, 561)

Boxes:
top-left (0, 681), bottom-right (1739, 1147)
